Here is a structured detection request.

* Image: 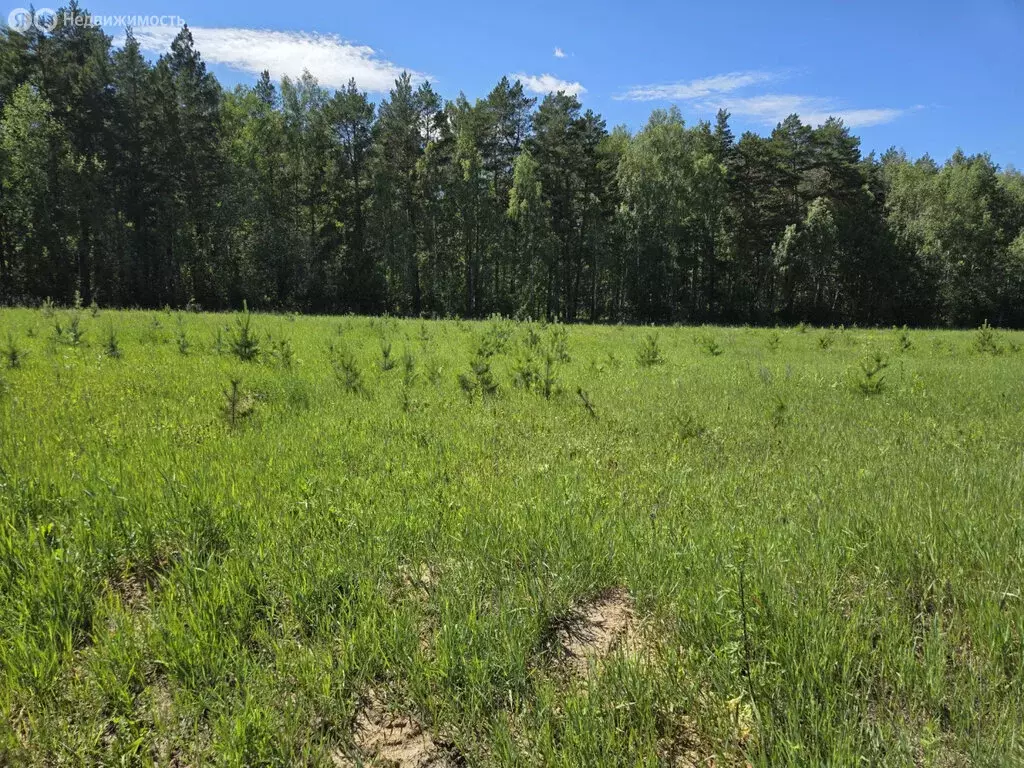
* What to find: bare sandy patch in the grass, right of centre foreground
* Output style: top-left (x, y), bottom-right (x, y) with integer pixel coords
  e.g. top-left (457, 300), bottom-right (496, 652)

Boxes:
top-left (558, 589), bottom-right (637, 677)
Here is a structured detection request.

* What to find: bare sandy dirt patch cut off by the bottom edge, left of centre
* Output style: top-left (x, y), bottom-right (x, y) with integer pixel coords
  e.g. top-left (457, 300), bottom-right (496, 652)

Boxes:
top-left (332, 694), bottom-right (460, 768)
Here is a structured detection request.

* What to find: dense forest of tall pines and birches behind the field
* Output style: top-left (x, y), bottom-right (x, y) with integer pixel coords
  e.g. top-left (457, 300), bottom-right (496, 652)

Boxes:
top-left (0, 15), bottom-right (1024, 327)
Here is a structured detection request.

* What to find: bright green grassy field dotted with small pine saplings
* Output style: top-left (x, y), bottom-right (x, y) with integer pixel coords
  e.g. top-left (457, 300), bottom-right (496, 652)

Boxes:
top-left (0, 309), bottom-right (1024, 768)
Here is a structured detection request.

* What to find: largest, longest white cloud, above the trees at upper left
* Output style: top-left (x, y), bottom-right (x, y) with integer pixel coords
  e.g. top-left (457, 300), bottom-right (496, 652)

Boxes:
top-left (135, 27), bottom-right (426, 92)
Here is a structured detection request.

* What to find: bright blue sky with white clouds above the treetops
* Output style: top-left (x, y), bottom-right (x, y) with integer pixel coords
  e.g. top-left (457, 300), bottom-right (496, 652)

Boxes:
top-left (74, 0), bottom-right (1024, 168)
